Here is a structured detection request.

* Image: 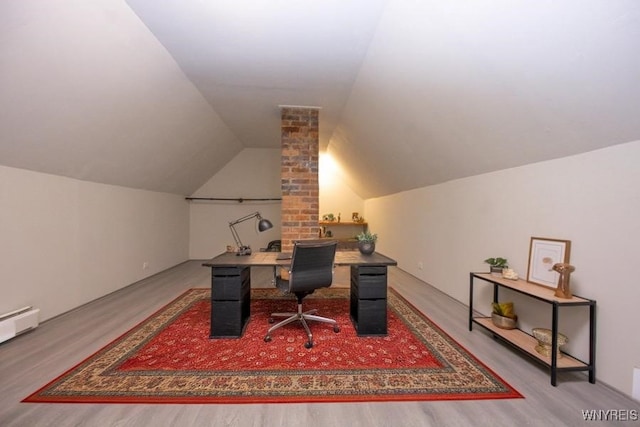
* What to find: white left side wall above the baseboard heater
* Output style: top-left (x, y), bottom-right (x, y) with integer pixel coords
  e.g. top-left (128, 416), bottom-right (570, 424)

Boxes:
top-left (0, 166), bottom-right (189, 320)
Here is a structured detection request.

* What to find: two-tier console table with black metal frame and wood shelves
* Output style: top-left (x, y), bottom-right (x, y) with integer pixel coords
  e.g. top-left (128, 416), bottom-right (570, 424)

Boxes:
top-left (469, 273), bottom-right (596, 386)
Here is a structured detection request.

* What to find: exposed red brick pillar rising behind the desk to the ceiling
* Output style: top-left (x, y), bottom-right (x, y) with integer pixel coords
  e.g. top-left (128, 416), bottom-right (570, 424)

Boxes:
top-left (280, 107), bottom-right (320, 252)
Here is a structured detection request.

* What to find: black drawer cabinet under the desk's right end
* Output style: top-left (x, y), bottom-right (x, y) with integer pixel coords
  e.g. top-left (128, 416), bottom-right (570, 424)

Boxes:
top-left (350, 265), bottom-right (387, 336)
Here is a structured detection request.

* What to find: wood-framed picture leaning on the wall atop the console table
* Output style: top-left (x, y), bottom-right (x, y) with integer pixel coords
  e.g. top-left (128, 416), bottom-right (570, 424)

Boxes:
top-left (527, 237), bottom-right (571, 288)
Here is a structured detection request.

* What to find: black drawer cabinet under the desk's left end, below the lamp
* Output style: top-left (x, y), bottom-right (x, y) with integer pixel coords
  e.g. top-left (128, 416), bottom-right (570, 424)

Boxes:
top-left (210, 267), bottom-right (251, 338)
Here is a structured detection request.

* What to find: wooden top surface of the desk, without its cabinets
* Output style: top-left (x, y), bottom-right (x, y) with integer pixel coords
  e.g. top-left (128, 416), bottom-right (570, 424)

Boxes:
top-left (202, 251), bottom-right (398, 267)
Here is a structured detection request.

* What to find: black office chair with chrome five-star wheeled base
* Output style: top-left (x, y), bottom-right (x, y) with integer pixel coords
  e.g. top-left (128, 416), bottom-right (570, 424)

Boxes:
top-left (264, 240), bottom-right (340, 348)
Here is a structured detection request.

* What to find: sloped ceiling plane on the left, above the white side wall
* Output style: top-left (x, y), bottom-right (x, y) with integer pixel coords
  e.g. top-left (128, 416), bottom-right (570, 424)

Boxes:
top-left (0, 0), bottom-right (243, 194)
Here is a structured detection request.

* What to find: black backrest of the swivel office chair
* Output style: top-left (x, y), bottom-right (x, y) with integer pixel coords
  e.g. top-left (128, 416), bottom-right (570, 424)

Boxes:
top-left (289, 240), bottom-right (338, 293)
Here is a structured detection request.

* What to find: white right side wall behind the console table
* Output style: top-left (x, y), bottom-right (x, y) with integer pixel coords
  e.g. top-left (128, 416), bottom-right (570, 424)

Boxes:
top-left (365, 141), bottom-right (640, 394)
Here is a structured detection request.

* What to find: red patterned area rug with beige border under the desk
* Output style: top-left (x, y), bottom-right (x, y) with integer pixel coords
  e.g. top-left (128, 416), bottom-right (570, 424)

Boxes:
top-left (24, 288), bottom-right (522, 403)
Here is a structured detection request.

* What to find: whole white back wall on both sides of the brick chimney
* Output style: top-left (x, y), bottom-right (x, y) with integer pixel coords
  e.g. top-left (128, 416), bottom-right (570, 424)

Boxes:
top-left (189, 148), bottom-right (364, 259)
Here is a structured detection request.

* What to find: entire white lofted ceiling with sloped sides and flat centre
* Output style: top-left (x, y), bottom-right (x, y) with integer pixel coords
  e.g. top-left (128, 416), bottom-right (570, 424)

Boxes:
top-left (0, 0), bottom-right (640, 198)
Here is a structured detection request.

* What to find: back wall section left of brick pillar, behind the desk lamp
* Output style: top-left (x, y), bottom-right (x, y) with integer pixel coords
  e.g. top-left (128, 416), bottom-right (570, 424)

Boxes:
top-left (189, 148), bottom-right (282, 259)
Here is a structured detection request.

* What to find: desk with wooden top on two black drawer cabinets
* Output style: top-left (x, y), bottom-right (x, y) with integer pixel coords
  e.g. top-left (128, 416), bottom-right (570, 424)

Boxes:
top-left (202, 251), bottom-right (398, 338)
